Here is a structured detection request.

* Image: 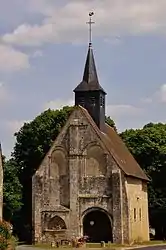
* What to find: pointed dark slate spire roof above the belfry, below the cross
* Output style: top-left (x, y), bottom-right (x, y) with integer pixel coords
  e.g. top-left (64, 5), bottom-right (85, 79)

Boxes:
top-left (74, 43), bottom-right (105, 93)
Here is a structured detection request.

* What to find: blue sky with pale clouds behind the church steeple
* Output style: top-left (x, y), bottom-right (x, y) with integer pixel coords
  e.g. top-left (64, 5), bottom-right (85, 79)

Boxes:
top-left (0, 0), bottom-right (166, 157)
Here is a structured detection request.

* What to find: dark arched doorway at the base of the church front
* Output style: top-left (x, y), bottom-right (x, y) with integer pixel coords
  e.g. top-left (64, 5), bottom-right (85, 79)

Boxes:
top-left (83, 209), bottom-right (112, 242)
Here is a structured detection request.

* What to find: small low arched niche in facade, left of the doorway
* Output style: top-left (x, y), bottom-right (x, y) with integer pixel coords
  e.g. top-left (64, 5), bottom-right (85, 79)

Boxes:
top-left (48, 215), bottom-right (67, 230)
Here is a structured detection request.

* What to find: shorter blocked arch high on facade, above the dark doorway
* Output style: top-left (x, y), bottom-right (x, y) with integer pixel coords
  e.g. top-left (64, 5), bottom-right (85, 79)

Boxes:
top-left (85, 143), bottom-right (107, 176)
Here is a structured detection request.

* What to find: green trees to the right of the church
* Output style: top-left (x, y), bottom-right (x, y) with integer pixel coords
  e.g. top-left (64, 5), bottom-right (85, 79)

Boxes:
top-left (121, 123), bottom-right (166, 236)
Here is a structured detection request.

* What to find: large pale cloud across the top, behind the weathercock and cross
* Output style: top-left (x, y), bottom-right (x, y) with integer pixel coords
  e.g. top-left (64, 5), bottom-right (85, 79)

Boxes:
top-left (2, 0), bottom-right (166, 46)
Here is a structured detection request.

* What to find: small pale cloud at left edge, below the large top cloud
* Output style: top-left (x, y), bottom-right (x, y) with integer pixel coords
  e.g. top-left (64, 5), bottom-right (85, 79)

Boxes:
top-left (0, 44), bottom-right (29, 72)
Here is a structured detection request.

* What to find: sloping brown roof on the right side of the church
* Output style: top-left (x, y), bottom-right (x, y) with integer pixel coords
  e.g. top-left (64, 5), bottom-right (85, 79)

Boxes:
top-left (79, 106), bottom-right (149, 181)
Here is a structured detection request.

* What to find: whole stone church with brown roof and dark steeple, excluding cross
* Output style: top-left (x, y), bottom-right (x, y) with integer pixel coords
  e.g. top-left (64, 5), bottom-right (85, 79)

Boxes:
top-left (32, 44), bottom-right (149, 243)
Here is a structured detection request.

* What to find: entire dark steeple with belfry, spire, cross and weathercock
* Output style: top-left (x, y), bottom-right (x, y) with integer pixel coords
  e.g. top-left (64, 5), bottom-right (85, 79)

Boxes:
top-left (74, 12), bottom-right (106, 132)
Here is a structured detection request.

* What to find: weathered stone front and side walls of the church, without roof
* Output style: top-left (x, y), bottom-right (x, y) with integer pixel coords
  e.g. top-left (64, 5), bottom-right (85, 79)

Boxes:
top-left (32, 107), bottom-right (149, 243)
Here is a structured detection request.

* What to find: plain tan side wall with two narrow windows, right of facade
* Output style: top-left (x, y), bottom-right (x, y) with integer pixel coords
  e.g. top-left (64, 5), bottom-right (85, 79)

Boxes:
top-left (126, 177), bottom-right (149, 242)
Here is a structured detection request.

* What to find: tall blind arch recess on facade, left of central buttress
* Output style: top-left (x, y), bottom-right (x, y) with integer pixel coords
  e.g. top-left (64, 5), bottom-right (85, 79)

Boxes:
top-left (50, 147), bottom-right (70, 207)
